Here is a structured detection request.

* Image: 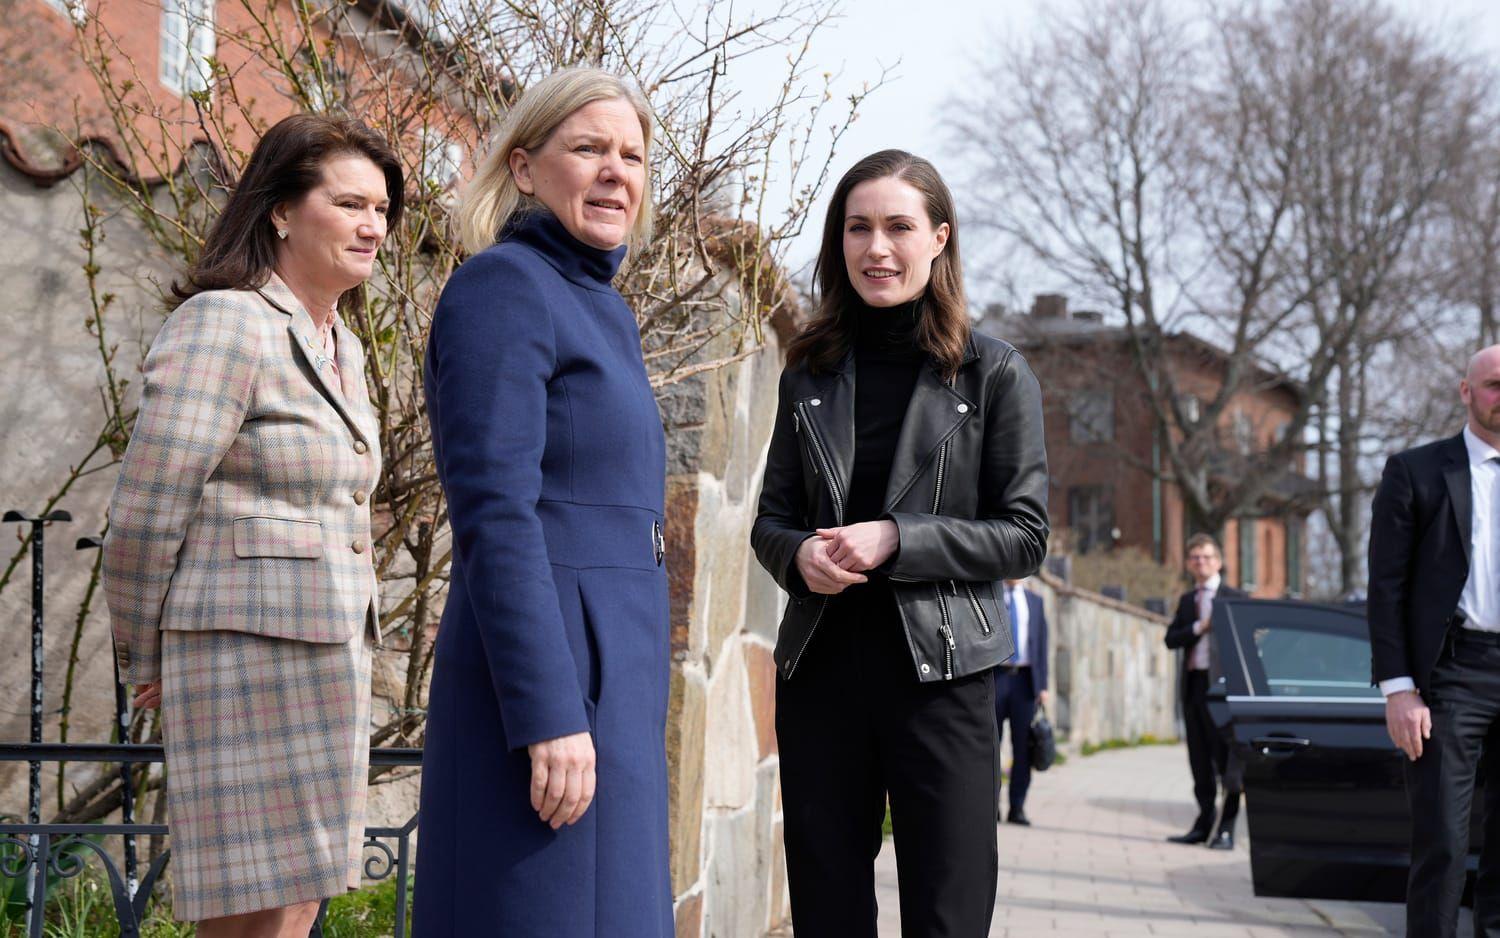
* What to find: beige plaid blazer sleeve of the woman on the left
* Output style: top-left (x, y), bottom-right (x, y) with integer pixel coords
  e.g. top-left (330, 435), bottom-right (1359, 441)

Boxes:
top-left (102, 293), bottom-right (260, 684)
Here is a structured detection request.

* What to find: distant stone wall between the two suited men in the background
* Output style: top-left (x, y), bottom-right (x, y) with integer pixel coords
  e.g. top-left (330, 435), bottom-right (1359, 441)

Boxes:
top-left (1026, 573), bottom-right (1178, 744)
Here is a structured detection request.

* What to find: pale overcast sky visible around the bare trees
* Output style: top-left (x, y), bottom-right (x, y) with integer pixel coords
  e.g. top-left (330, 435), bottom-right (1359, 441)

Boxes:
top-left (755, 0), bottom-right (1500, 288)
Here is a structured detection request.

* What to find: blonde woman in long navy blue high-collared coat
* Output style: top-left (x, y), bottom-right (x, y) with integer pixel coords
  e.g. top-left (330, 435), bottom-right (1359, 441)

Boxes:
top-left (414, 69), bottom-right (672, 938)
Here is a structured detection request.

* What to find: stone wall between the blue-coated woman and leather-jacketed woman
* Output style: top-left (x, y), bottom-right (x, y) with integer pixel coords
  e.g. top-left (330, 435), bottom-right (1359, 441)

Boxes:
top-left (662, 312), bottom-right (789, 938)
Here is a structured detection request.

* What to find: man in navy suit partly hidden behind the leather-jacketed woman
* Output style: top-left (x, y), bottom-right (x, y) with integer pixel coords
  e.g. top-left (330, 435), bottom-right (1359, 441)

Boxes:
top-left (995, 579), bottom-right (1049, 825)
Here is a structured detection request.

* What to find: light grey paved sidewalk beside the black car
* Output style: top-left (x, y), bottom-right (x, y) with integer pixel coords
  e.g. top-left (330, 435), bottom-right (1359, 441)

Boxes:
top-left (876, 746), bottom-right (1446, 938)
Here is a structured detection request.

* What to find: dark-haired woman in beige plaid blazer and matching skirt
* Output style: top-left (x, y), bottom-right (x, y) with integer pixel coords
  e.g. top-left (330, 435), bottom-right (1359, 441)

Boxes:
top-left (104, 114), bottom-right (402, 938)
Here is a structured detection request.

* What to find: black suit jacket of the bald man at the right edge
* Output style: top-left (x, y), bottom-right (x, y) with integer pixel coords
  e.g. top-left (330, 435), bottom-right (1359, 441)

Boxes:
top-left (1368, 434), bottom-right (1473, 695)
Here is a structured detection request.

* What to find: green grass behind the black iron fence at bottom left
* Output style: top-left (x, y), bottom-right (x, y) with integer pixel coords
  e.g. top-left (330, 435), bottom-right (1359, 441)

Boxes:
top-left (0, 869), bottom-right (411, 938)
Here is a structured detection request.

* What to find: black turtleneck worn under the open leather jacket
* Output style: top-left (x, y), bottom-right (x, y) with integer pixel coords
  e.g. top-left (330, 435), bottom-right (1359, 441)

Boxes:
top-left (845, 300), bottom-right (927, 524)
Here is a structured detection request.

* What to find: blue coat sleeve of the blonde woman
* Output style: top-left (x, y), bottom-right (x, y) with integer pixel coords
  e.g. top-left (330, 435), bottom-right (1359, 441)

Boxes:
top-left (426, 252), bottom-right (588, 749)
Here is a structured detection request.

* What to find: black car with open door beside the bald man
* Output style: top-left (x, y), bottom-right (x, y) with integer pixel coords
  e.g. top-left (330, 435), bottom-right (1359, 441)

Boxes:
top-left (1209, 599), bottom-right (1484, 902)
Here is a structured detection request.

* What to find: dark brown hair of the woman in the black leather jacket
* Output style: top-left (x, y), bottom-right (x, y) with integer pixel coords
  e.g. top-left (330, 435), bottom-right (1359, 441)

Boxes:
top-left (786, 150), bottom-right (969, 378)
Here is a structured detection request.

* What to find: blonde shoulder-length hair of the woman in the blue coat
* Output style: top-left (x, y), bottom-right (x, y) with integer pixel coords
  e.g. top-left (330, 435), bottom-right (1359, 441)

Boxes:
top-left (455, 68), bottom-right (651, 254)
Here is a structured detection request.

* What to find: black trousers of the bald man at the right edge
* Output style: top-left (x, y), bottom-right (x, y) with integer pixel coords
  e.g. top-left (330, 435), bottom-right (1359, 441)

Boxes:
top-left (1403, 627), bottom-right (1500, 938)
